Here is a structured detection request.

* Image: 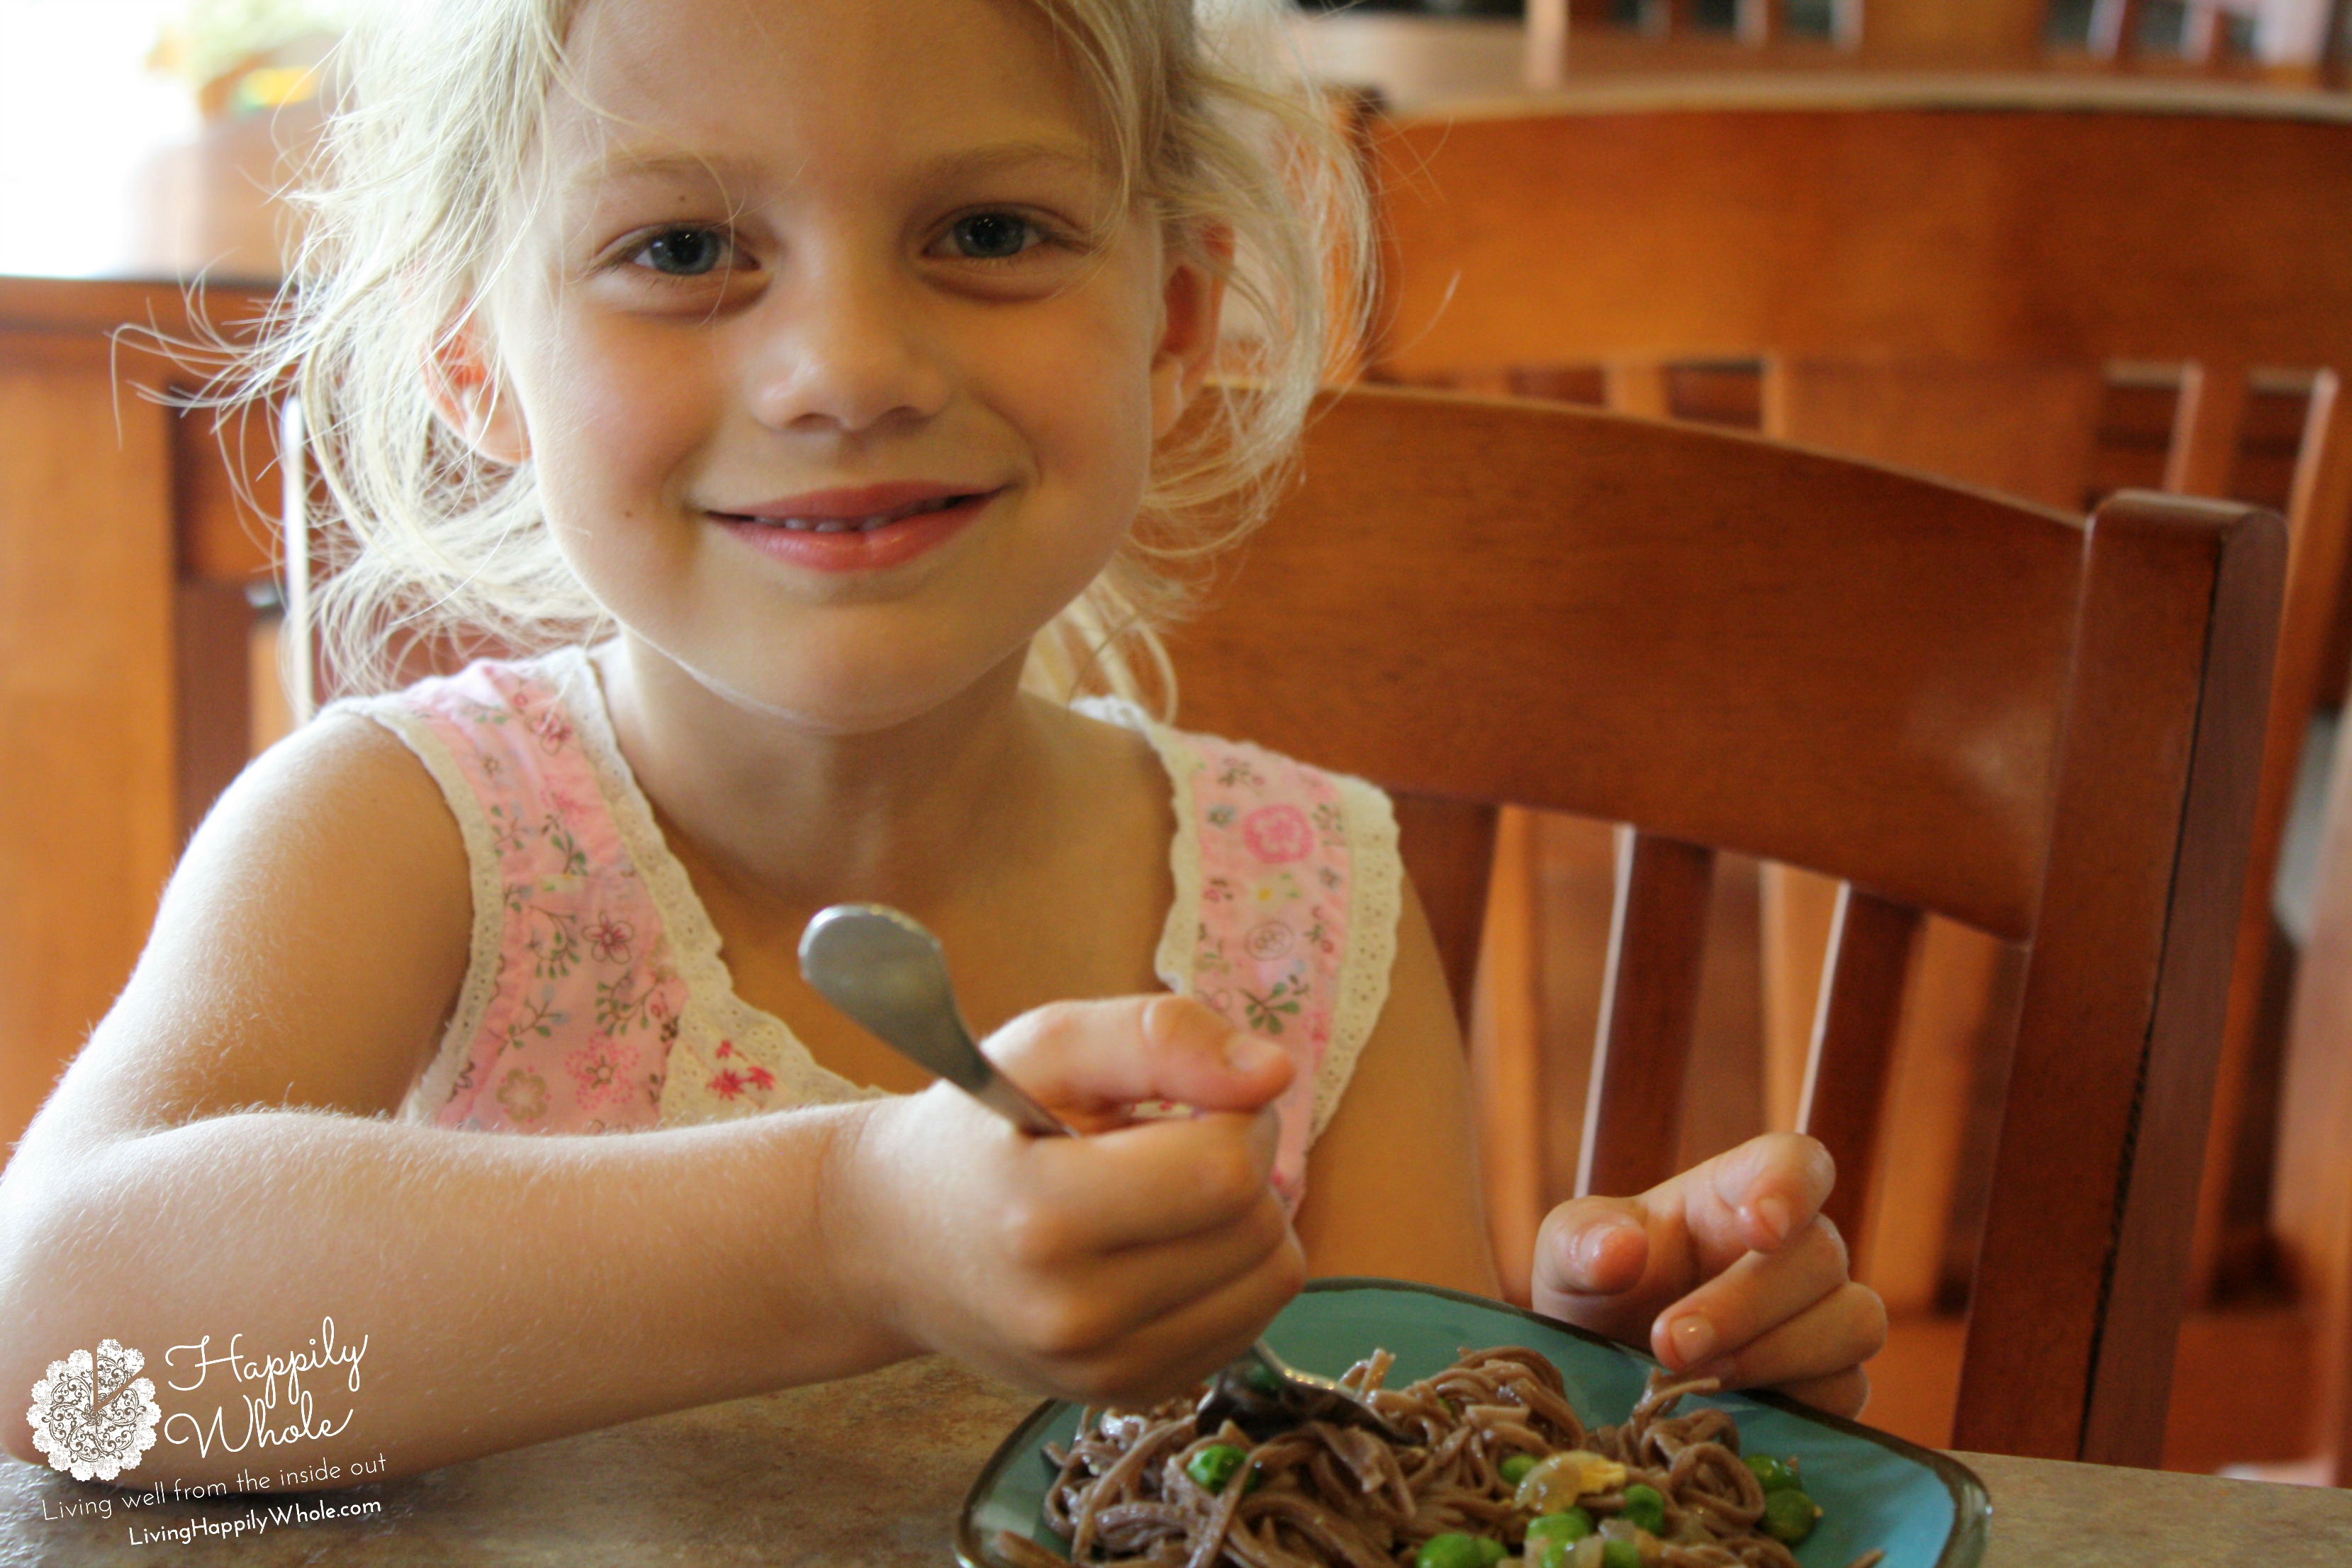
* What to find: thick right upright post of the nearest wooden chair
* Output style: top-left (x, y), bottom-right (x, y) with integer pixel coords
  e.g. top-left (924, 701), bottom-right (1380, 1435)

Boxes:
top-left (1954, 493), bottom-right (2284, 1465)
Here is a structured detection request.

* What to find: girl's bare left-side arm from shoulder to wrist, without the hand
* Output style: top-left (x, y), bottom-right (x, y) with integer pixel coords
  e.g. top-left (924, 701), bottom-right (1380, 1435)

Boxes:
top-left (0, 719), bottom-right (896, 1484)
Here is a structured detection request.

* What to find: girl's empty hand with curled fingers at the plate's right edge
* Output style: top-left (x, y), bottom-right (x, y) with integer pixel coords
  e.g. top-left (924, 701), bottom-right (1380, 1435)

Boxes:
top-left (1533, 1133), bottom-right (1886, 1415)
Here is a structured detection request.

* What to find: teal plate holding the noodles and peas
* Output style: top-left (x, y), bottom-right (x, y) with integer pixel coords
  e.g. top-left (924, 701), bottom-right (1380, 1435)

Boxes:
top-left (955, 1279), bottom-right (1992, 1568)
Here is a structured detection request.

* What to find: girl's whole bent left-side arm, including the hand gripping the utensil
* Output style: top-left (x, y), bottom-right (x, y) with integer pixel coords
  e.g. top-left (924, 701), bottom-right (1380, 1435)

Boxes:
top-left (0, 719), bottom-right (1301, 1484)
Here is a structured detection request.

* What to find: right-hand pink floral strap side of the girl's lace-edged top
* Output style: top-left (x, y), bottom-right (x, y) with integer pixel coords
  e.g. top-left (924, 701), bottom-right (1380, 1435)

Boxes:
top-left (1075, 698), bottom-right (1404, 1203)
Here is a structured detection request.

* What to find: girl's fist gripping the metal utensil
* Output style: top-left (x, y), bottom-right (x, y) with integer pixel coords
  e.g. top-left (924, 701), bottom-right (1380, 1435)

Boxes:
top-left (826, 997), bottom-right (1305, 1404)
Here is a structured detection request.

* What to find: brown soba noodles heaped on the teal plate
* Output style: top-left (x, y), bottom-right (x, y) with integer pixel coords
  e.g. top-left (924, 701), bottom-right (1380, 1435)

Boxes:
top-left (992, 1347), bottom-right (1879, 1568)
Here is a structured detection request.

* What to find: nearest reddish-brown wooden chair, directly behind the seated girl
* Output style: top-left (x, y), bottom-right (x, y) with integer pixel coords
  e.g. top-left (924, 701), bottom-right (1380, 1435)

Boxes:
top-left (1174, 388), bottom-right (2284, 1465)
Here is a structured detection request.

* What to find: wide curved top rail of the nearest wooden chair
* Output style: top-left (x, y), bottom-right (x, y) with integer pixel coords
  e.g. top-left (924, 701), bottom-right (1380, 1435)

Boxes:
top-left (1171, 388), bottom-right (2081, 941)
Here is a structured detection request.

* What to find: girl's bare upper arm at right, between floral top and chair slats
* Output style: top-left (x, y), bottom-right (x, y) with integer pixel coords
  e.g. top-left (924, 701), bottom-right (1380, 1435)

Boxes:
top-left (1299, 877), bottom-right (1503, 1298)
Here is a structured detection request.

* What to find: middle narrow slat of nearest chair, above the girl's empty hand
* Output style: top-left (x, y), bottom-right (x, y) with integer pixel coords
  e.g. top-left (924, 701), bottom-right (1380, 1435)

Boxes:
top-left (1576, 827), bottom-right (1715, 1197)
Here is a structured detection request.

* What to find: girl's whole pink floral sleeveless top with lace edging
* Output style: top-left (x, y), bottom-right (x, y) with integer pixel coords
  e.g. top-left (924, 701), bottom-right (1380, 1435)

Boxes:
top-left (336, 649), bottom-right (1399, 1206)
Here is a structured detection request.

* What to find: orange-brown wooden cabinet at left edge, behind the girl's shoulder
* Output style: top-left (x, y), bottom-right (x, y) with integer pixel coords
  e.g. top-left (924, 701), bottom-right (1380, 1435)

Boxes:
top-left (0, 277), bottom-right (268, 1165)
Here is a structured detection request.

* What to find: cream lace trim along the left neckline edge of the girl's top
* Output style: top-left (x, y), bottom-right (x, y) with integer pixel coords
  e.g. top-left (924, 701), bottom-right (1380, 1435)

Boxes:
top-left (548, 649), bottom-right (887, 1126)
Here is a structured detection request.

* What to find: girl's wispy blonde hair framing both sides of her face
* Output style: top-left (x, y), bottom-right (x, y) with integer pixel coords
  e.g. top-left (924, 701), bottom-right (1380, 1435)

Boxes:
top-left (235, 0), bottom-right (1371, 712)
